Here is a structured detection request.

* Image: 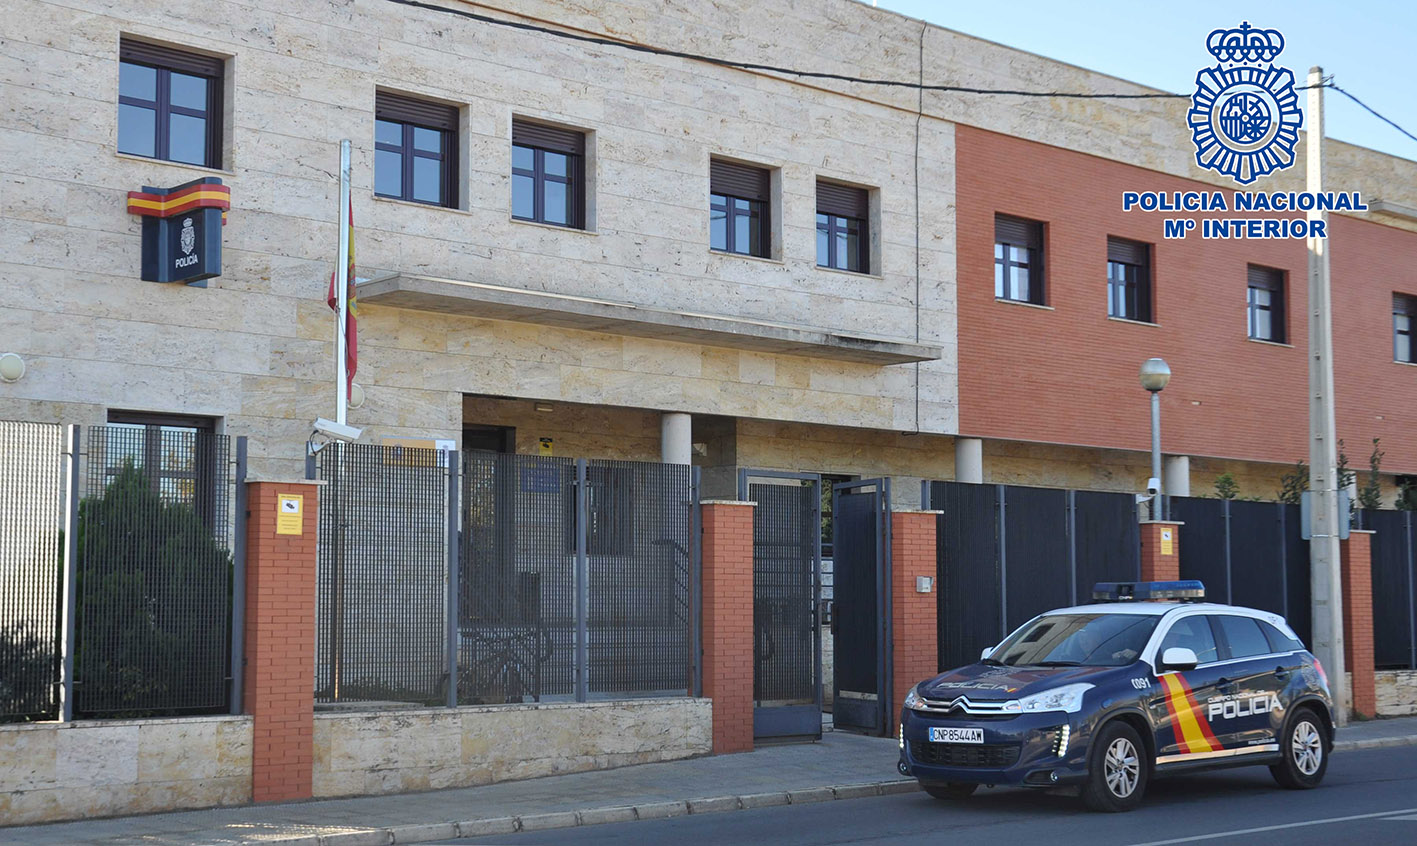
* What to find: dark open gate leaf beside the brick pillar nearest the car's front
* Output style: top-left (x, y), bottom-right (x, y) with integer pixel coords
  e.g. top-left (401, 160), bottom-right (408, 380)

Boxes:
top-left (832, 479), bottom-right (894, 734)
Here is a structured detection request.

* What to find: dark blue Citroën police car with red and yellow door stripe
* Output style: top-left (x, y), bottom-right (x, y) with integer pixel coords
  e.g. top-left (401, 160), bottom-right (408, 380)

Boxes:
top-left (898, 581), bottom-right (1333, 812)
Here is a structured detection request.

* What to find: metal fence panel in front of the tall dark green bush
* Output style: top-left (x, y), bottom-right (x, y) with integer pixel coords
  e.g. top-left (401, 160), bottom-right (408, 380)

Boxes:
top-left (74, 424), bottom-right (241, 717)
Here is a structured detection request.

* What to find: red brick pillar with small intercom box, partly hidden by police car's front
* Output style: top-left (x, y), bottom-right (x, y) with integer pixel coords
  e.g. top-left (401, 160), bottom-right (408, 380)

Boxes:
top-left (888, 512), bottom-right (939, 734)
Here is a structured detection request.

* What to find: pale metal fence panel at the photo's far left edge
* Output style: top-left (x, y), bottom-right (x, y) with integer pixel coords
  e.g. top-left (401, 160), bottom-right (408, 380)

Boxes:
top-left (0, 421), bottom-right (65, 720)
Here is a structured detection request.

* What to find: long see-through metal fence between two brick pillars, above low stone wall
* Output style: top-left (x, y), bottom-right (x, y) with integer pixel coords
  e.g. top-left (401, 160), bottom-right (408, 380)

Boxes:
top-left (315, 444), bottom-right (699, 704)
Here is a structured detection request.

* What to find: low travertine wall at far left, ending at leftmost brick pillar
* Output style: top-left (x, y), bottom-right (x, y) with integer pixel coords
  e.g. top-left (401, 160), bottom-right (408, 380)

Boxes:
top-left (0, 717), bottom-right (251, 825)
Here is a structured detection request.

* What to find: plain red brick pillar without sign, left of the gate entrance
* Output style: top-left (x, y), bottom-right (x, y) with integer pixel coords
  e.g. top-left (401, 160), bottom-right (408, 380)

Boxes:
top-left (703, 502), bottom-right (752, 755)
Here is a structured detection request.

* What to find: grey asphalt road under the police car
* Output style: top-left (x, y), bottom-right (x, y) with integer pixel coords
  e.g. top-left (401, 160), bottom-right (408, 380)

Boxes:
top-left (446, 747), bottom-right (1417, 846)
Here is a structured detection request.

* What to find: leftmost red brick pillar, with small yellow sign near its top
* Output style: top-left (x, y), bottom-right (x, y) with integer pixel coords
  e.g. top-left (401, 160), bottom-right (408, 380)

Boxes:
top-left (245, 482), bottom-right (319, 802)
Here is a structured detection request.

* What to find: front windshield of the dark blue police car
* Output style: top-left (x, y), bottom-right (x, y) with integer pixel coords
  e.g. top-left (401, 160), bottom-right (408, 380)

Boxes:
top-left (989, 614), bottom-right (1161, 667)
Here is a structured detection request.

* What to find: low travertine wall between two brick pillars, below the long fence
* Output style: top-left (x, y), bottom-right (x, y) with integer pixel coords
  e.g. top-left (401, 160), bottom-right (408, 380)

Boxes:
top-left (315, 699), bottom-right (711, 796)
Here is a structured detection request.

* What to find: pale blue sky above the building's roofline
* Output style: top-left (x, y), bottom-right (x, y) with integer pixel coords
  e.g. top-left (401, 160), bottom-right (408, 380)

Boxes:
top-left (866, 0), bottom-right (1417, 160)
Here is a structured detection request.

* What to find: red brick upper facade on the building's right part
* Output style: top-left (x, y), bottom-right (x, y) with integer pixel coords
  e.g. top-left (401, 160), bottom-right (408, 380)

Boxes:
top-left (955, 126), bottom-right (1417, 478)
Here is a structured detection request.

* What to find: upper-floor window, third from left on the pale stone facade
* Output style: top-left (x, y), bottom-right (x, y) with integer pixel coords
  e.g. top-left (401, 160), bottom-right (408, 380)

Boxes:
top-left (512, 120), bottom-right (585, 230)
